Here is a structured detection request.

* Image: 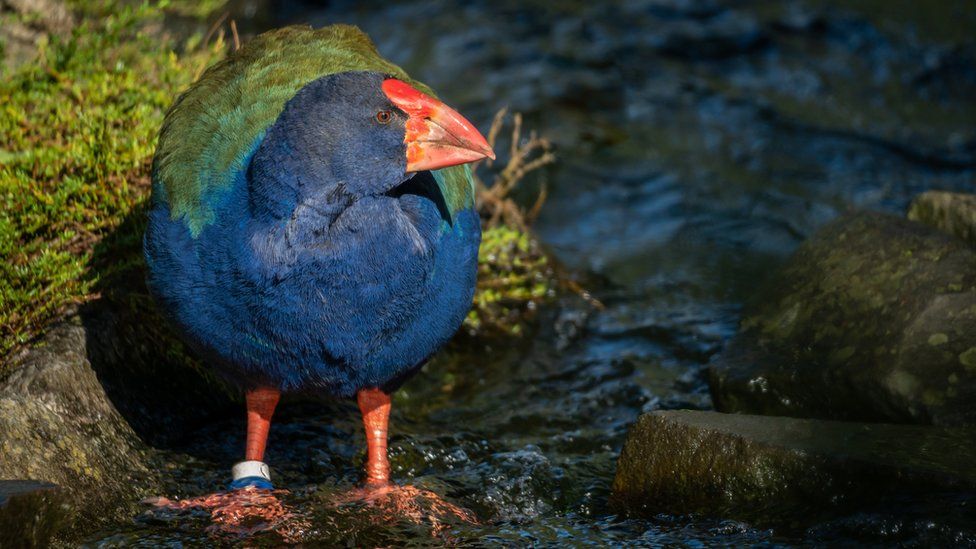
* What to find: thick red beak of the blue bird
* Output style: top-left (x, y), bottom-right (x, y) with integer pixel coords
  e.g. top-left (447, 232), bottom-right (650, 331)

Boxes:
top-left (383, 78), bottom-right (495, 172)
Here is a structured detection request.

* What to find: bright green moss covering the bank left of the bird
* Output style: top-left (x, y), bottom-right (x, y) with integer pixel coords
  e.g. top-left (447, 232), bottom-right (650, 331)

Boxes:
top-left (0, 1), bottom-right (223, 362)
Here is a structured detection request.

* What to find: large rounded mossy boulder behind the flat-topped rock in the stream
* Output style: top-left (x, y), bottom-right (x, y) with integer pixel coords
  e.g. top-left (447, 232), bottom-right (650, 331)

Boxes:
top-left (709, 213), bottom-right (976, 425)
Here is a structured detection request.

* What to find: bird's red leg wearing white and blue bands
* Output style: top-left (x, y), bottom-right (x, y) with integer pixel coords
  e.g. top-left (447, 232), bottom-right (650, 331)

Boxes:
top-left (230, 387), bottom-right (281, 490)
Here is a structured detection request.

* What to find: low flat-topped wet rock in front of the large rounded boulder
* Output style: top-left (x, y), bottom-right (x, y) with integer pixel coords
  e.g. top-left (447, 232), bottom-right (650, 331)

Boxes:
top-left (611, 411), bottom-right (976, 528)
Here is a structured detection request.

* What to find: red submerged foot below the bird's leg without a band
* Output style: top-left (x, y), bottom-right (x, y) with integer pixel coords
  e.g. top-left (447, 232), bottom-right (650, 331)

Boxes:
top-left (334, 483), bottom-right (478, 535)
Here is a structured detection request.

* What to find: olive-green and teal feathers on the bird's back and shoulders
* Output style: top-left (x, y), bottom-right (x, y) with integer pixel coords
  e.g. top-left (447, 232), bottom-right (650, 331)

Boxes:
top-left (153, 25), bottom-right (474, 235)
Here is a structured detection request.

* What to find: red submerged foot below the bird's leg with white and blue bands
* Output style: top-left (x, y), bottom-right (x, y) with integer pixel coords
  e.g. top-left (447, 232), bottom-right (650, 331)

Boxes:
top-left (144, 486), bottom-right (310, 543)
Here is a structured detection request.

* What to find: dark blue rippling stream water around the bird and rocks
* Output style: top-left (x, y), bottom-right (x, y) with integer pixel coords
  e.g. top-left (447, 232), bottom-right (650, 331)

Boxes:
top-left (89, 0), bottom-right (976, 546)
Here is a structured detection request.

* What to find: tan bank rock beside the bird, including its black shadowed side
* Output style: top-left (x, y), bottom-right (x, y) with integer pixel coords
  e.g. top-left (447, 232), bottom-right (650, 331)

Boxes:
top-left (0, 300), bottom-right (233, 532)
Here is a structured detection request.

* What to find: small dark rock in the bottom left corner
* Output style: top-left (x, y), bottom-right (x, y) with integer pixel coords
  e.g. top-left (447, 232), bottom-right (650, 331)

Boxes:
top-left (0, 480), bottom-right (67, 547)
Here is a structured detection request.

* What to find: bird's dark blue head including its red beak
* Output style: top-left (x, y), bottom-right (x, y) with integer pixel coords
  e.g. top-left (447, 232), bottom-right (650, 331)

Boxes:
top-left (252, 71), bottom-right (495, 206)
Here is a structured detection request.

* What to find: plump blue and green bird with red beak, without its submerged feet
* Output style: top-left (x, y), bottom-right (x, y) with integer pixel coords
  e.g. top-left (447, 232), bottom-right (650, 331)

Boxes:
top-left (144, 25), bottom-right (494, 489)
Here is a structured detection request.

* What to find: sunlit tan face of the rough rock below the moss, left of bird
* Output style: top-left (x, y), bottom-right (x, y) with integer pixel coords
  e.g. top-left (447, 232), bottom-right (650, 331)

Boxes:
top-left (0, 319), bottom-right (157, 521)
